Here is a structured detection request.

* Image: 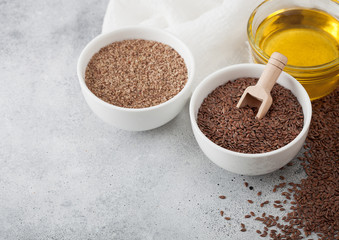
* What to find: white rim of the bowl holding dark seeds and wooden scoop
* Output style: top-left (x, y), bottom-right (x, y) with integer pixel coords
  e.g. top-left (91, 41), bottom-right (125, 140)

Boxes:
top-left (189, 63), bottom-right (312, 160)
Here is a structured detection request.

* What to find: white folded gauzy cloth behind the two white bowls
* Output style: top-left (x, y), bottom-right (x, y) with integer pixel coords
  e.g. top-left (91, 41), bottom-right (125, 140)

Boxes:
top-left (102, 0), bottom-right (262, 87)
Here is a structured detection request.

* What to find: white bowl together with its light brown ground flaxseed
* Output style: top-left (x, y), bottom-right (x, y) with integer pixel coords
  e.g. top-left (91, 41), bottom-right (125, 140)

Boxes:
top-left (77, 27), bottom-right (194, 131)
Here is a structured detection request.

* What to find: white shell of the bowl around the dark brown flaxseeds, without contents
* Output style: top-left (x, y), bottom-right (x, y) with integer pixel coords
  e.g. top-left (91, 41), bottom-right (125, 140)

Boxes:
top-left (190, 64), bottom-right (312, 175)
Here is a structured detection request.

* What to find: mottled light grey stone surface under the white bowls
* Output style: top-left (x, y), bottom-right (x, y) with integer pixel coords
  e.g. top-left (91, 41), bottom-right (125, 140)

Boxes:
top-left (0, 0), bottom-right (304, 240)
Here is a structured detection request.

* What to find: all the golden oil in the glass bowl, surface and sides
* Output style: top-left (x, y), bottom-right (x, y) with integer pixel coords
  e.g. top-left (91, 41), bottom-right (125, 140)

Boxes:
top-left (252, 8), bottom-right (339, 100)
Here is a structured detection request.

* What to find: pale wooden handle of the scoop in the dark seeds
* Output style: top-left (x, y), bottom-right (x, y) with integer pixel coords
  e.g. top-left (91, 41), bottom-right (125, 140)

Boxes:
top-left (257, 52), bottom-right (287, 93)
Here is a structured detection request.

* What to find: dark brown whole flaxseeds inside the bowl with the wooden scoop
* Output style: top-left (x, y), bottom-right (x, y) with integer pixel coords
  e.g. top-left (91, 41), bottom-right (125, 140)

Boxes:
top-left (197, 78), bottom-right (304, 153)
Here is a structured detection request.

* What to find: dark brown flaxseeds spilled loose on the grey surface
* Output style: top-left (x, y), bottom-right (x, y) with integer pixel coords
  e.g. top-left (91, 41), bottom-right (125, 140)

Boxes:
top-left (218, 88), bottom-right (339, 240)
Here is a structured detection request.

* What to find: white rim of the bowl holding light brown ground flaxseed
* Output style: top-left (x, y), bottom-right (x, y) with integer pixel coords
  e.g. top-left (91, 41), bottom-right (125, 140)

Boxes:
top-left (77, 26), bottom-right (195, 112)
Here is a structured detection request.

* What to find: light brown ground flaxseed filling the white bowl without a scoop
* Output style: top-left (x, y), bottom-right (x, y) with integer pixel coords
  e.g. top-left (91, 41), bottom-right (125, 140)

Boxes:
top-left (85, 39), bottom-right (188, 108)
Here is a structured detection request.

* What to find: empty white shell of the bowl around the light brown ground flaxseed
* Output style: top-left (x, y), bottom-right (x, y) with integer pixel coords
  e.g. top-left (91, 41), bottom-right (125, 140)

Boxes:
top-left (77, 27), bottom-right (195, 131)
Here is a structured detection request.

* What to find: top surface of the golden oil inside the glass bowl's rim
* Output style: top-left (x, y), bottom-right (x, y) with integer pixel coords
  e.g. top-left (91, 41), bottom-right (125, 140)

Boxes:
top-left (255, 9), bottom-right (339, 67)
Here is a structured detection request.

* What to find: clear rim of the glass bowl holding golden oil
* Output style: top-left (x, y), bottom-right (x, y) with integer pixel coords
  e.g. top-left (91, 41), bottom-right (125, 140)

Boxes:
top-left (246, 0), bottom-right (339, 72)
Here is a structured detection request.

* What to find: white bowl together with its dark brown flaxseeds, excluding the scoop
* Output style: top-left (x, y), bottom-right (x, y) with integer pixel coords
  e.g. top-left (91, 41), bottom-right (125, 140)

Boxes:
top-left (190, 64), bottom-right (312, 175)
